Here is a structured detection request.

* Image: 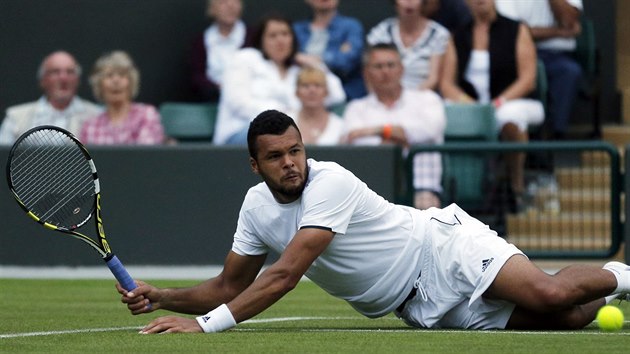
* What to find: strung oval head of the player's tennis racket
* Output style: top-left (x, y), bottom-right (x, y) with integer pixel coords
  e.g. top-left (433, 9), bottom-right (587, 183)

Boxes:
top-left (11, 129), bottom-right (96, 229)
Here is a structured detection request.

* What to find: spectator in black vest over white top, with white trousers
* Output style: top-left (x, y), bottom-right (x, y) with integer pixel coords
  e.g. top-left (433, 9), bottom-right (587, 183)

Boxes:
top-left (440, 0), bottom-right (545, 208)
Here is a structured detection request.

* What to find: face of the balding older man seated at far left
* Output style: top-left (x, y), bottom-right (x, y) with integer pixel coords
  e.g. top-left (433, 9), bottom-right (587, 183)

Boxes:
top-left (40, 53), bottom-right (79, 108)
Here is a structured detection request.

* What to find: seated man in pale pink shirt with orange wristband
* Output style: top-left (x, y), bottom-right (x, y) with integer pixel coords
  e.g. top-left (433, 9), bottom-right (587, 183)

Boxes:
top-left (343, 44), bottom-right (446, 209)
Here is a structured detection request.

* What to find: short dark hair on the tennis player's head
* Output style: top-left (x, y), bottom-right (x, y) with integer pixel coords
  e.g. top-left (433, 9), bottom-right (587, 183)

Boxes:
top-left (247, 109), bottom-right (301, 159)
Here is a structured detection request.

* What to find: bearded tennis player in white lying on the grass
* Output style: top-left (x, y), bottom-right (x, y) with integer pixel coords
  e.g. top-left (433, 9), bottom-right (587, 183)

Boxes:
top-left (117, 111), bottom-right (630, 333)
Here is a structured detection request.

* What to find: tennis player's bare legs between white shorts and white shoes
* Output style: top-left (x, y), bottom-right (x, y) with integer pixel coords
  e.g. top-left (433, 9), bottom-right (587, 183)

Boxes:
top-left (484, 255), bottom-right (617, 329)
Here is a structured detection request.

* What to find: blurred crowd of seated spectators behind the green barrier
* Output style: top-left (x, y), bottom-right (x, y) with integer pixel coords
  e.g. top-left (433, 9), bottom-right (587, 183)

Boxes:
top-left (0, 0), bottom-right (582, 208)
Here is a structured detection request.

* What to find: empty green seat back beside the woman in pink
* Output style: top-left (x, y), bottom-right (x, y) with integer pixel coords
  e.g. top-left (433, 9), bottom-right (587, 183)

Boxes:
top-left (160, 102), bottom-right (217, 142)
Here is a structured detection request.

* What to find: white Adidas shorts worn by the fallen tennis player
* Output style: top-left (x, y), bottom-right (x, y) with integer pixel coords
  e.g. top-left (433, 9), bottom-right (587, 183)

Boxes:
top-left (396, 204), bottom-right (524, 329)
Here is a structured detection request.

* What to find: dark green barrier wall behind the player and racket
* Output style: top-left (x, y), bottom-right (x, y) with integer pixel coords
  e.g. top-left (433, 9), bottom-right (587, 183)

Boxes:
top-left (0, 145), bottom-right (401, 266)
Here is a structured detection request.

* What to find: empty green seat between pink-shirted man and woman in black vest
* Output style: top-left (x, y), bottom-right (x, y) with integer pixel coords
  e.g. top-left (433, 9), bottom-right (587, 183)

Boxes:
top-left (442, 104), bottom-right (498, 210)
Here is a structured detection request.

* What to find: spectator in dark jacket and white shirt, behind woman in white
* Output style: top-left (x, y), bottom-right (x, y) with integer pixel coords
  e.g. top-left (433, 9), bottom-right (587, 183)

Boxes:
top-left (190, 0), bottom-right (252, 102)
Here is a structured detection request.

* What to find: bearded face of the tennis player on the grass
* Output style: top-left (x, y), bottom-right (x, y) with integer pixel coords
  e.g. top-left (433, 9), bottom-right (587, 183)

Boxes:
top-left (250, 127), bottom-right (308, 204)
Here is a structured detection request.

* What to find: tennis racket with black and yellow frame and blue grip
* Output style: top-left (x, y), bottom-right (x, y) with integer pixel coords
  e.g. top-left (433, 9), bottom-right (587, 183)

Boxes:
top-left (7, 126), bottom-right (142, 291)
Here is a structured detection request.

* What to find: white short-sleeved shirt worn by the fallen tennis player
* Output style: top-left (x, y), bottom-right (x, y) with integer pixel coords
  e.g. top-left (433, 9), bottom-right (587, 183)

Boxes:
top-left (232, 159), bottom-right (426, 317)
